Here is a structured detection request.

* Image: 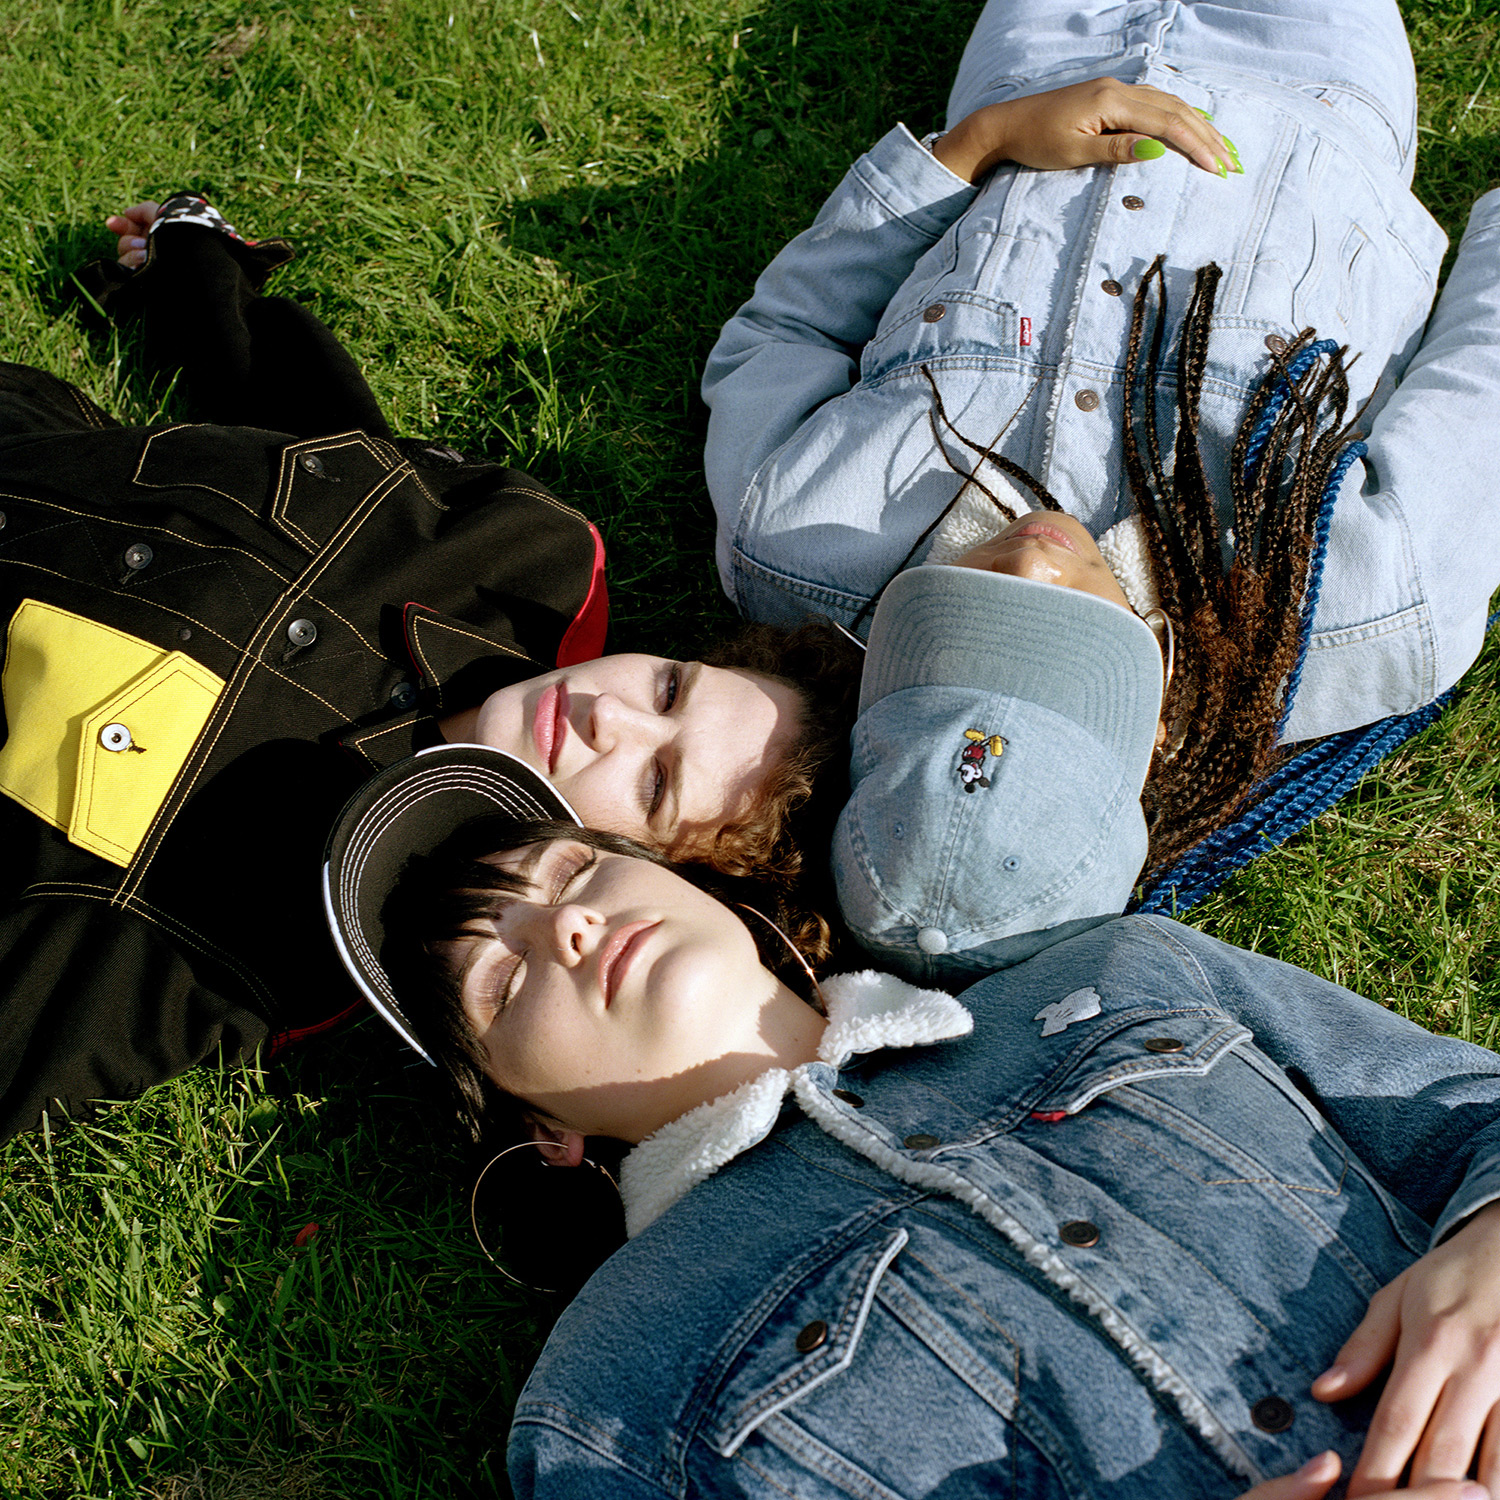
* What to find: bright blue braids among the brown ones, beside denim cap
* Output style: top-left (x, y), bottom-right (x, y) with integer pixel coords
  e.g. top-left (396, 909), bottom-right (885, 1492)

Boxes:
top-left (1133, 339), bottom-right (1464, 917)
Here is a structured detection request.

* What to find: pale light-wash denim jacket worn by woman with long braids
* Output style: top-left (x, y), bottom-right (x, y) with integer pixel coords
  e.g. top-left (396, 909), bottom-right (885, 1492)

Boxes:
top-left (702, 66), bottom-right (1500, 741)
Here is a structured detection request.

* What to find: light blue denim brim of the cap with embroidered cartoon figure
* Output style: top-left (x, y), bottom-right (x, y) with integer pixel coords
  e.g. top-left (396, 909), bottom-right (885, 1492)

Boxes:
top-left (860, 566), bottom-right (1163, 785)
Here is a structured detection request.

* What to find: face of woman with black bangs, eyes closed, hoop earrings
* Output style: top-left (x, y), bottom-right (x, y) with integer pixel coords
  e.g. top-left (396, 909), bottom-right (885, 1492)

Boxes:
top-left (449, 840), bottom-right (824, 1142)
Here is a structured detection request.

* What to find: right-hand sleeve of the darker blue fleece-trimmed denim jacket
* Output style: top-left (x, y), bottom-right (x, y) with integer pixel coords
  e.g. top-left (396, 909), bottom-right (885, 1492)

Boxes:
top-left (1173, 929), bottom-right (1500, 1245)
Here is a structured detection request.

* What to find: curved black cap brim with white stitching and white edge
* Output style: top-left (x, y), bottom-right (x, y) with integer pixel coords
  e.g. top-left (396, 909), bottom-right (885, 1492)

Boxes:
top-left (323, 744), bottom-right (584, 1062)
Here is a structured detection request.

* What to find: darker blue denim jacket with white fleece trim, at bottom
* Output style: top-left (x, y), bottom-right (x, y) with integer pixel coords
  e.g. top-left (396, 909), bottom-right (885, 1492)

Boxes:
top-left (509, 917), bottom-right (1500, 1500)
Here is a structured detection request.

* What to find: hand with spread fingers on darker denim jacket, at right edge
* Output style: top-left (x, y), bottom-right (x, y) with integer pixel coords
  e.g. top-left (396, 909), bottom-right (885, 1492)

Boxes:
top-left (1313, 1203), bottom-right (1500, 1500)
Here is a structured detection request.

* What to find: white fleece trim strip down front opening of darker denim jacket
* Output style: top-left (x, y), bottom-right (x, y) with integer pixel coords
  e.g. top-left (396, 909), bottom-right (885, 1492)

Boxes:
top-left (792, 1077), bottom-right (1262, 1482)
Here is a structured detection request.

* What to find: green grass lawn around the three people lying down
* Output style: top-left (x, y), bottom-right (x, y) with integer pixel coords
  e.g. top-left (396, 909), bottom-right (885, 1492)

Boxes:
top-left (0, 0), bottom-right (1500, 1500)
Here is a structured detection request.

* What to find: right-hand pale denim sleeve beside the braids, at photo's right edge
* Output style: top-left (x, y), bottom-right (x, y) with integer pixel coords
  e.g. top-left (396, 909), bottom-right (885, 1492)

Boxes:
top-left (1286, 189), bottom-right (1500, 741)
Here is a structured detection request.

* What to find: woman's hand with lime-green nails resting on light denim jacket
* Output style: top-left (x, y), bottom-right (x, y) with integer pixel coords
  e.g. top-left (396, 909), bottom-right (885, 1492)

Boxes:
top-left (933, 78), bottom-right (1244, 183)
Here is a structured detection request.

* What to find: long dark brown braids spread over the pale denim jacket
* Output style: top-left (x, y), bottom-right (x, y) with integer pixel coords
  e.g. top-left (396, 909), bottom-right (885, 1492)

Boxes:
top-left (888, 255), bottom-right (1358, 873)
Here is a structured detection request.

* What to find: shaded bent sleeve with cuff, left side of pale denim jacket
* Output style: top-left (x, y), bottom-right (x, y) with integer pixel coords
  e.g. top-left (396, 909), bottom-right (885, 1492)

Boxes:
top-left (702, 125), bottom-right (975, 591)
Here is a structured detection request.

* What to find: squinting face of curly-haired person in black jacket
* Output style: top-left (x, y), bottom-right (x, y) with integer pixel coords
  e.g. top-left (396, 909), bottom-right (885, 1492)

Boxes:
top-left (443, 656), bottom-right (801, 854)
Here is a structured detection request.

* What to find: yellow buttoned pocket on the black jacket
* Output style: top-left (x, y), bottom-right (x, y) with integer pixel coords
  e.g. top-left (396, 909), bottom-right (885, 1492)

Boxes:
top-left (0, 599), bottom-right (224, 866)
